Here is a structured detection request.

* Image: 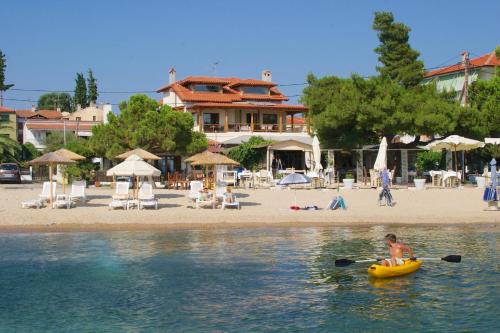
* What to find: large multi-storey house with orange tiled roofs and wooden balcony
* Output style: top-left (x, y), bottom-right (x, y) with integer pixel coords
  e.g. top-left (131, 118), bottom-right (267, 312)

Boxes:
top-left (157, 68), bottom-right (312, 169)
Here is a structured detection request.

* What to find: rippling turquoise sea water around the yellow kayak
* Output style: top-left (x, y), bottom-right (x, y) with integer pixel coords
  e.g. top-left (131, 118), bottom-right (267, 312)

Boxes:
top-left (0, 226), bottom-right (500, 332)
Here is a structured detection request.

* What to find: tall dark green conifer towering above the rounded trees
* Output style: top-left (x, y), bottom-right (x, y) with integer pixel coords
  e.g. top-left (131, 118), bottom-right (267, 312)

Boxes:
top-left (373, 12), bottom-right (424, 88)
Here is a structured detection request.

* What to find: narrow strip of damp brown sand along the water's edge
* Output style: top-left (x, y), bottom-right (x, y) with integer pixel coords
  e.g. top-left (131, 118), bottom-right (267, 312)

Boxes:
top-left (0, 222), bottom-right (500, 234)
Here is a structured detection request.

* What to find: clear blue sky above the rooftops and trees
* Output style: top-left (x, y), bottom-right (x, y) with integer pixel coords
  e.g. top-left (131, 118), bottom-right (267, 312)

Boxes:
top-left (0, 0), bottom-right (500, 111)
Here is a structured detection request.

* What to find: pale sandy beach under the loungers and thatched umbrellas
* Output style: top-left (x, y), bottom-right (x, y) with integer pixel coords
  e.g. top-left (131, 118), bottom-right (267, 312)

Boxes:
top-left (0, 184), bottom-right (500, 232)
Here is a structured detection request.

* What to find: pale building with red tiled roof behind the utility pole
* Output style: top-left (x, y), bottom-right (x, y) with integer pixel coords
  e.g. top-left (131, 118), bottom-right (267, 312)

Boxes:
top-left (423, 51), bottom-right (500, 102)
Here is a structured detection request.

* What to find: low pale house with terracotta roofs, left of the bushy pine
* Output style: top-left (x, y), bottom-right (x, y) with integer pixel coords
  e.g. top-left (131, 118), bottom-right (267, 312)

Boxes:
top-left (16, 104), bottom-right (112, 150)
